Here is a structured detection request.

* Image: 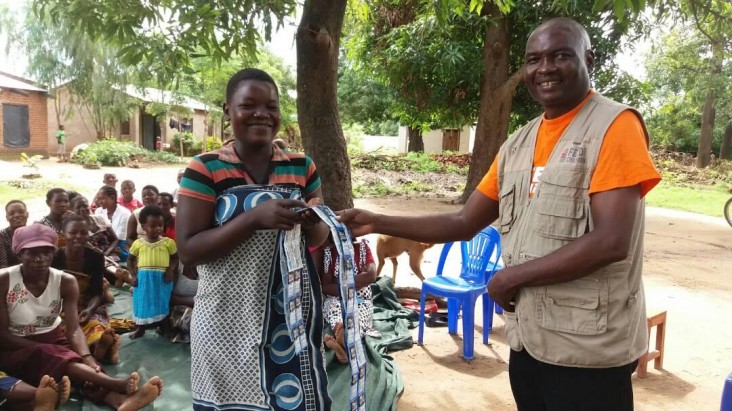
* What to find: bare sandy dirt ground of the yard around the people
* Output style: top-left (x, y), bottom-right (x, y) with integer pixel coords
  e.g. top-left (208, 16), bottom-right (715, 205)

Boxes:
top-left (0, 160), bottom-right (732, 411)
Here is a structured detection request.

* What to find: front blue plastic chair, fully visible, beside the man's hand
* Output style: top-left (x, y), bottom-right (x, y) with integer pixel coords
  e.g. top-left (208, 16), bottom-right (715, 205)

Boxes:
top-left (417, 226), bottom-right (501, 361)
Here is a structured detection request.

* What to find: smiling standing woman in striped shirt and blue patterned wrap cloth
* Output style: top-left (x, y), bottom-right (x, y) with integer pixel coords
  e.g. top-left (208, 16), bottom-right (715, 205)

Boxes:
top-left (176, 69), bottom-right (330, 411)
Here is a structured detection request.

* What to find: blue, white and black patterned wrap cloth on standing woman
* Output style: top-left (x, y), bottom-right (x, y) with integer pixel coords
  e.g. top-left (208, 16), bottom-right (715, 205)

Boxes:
top-left (191, 185), bottom-right (331, 411)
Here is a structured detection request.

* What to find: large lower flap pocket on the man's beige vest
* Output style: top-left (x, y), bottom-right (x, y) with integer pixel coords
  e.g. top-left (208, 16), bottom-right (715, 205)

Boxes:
top-left (536, 278), bottom-right (608, 335)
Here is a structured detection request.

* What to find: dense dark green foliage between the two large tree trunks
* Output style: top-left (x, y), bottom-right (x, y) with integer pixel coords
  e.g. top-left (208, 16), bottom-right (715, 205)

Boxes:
top-left (345, 8), bottom-right (487, 128)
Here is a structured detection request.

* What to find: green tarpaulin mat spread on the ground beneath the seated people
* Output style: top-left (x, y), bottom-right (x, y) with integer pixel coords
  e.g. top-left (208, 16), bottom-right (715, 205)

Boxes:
top-left (62, 277), bottom-right (417, 411)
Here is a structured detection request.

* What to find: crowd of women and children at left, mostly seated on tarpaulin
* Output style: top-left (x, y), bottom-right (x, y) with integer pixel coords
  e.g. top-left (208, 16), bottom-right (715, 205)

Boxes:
top-left (0, 182), bottom-right (192, 410)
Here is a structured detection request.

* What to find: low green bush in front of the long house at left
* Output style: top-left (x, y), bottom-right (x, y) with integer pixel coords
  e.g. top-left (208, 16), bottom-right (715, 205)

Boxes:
top-left (71, 139), bottom-right (178, 167)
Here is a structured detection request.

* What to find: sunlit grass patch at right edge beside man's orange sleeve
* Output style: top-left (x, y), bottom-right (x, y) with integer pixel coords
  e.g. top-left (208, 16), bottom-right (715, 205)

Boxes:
top-left (646, 181), bottom-right (730, 217)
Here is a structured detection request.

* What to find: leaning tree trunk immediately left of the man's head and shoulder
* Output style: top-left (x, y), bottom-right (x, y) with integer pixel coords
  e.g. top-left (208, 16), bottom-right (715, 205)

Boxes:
top-left (460, 7), bottom-right (521, 203)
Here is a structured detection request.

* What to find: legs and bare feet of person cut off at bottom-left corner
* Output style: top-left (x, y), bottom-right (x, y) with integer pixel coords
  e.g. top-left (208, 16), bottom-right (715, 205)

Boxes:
top-left (0, 371), bottom-right (71, 411)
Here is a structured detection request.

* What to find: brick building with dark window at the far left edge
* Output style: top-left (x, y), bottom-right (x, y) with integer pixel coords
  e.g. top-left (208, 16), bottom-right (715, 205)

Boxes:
top-left (0, 72), bottom-right (49, 159)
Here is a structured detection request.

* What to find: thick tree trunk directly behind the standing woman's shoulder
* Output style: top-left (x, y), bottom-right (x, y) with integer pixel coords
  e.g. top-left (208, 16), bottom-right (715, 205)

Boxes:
top-left (296, 0), bottom-right (353, 210)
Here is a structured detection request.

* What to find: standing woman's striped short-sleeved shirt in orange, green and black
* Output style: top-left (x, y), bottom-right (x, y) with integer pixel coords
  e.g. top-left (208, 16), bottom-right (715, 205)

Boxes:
top-left (178, 141), bottom-right (320, 203)
